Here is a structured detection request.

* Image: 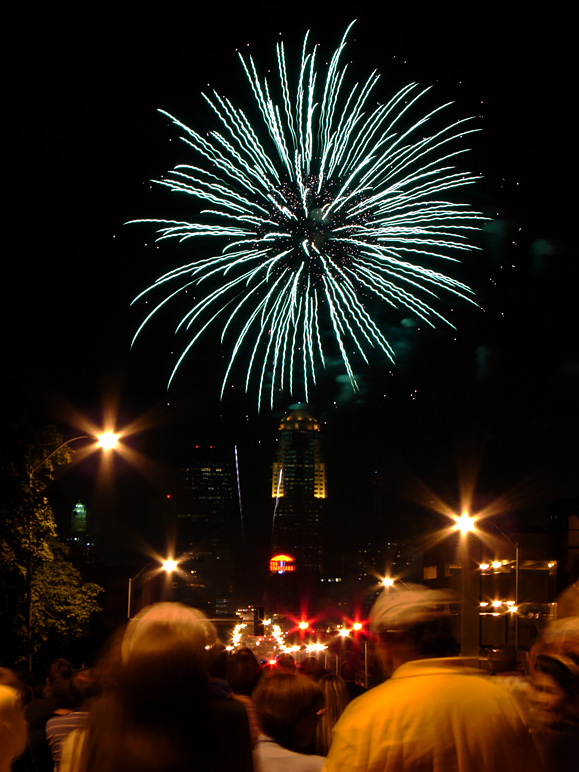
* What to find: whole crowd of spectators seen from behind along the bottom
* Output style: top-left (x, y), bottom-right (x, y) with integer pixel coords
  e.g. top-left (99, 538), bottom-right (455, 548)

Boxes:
top-left (0, 585), bottom-right (579, 772)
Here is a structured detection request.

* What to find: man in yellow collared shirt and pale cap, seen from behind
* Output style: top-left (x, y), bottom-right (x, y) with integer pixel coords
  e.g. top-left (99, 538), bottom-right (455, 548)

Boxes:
top-left (323, 585), bottom-right (542, 772)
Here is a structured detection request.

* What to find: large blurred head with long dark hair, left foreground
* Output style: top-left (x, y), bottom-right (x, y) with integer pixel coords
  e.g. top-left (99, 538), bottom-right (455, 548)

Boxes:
top-left (83, 603), bottom-right (213, 772)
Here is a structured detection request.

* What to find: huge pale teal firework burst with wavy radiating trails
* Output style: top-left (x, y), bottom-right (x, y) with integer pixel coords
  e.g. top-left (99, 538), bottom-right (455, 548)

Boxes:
top-left (133, 25), bottom-right (486, 407)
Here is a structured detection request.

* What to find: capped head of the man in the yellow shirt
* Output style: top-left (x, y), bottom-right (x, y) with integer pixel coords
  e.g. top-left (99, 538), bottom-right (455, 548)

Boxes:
top-left (370, 584), bottom-right (459, 675)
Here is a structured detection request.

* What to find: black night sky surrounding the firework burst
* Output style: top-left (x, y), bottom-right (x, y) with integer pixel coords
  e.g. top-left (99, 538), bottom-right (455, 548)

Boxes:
top-left (2, 3), bottom-right (579, 572)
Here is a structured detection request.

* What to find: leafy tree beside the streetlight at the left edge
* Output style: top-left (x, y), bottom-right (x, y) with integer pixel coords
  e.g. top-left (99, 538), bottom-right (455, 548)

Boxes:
top-left (0, 414), bottom-right (101, 663)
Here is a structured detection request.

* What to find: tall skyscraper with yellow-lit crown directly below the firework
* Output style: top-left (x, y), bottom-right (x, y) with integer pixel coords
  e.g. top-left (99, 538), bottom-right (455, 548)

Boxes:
top-left (271, 409), bottom-right (326, 575)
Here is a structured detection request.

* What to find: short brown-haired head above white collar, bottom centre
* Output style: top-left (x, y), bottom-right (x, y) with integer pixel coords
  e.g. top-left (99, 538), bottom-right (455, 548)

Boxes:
top-left (253, 671), bottom-right (324, 753)
